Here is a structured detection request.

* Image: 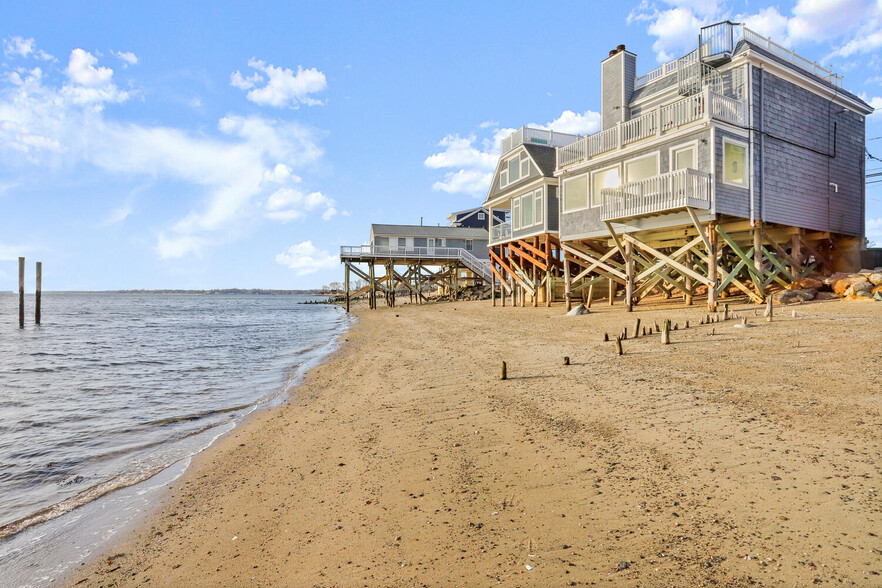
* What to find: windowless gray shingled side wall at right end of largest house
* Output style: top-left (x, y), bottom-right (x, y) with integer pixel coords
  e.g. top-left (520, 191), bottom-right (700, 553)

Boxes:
top-left (753, 68), bottom-right (864, 235)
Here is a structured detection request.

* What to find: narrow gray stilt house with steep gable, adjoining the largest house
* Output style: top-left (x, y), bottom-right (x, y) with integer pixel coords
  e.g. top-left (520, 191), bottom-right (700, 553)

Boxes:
top-left (484, 133), bottom-right (580, 306)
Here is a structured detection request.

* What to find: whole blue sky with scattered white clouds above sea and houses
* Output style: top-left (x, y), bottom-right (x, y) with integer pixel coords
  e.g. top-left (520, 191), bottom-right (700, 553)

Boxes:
top-left (0, 0), bottom-right (882, 291)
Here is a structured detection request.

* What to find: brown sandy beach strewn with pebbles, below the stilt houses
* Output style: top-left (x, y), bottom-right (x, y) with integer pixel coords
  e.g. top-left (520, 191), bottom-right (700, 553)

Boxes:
top-left (69, 301), bottom-right (882, 587)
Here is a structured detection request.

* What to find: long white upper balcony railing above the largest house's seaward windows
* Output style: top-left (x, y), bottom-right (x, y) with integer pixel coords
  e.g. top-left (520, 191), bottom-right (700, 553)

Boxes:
top-left (557, 87), bottom-right (747, 169)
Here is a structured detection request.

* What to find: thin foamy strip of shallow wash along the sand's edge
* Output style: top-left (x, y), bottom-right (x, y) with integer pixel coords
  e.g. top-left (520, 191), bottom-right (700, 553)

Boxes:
top-left (0, 306), bottom-right (354, 586)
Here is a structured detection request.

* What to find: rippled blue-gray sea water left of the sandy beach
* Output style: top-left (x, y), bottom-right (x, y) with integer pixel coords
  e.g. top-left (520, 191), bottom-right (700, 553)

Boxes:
top-left (0, 292), bottom-right (348, 585)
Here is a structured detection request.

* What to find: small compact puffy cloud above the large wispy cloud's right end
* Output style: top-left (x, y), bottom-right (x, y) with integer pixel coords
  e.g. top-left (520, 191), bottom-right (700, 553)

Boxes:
top-left (230, 59), bottom-right (328, 108)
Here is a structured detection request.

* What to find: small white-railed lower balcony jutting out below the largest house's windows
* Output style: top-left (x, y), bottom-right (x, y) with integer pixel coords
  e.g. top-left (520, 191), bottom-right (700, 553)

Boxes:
top-left (600, 169), bottom-right (711, 221)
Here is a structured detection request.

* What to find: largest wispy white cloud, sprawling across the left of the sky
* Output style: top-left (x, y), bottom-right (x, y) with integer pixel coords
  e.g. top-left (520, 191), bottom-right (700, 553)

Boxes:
top-left (0, 39), bottom-right (335, 257)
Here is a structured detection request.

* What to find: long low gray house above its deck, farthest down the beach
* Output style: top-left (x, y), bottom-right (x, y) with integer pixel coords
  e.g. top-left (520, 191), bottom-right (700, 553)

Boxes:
top-left (371, 225), bottom-right (487, 259)
